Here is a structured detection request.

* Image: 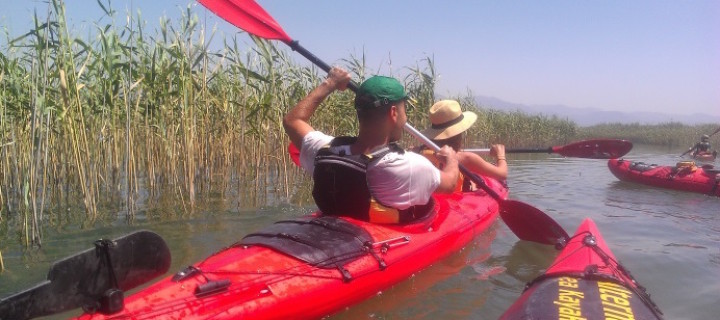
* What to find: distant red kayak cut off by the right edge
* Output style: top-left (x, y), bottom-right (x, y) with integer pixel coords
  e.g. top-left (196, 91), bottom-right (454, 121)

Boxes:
top-left (608, 159), bottom-right (720, 196)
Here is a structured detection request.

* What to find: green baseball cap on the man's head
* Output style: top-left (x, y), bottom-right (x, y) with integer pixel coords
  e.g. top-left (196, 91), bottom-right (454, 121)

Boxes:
top-left (355, 76), bottom-right (407, 109)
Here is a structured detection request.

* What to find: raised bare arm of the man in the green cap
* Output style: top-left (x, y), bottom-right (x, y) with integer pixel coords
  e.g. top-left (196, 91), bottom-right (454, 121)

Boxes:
top-left (283, 67), bottom-right (350, 148)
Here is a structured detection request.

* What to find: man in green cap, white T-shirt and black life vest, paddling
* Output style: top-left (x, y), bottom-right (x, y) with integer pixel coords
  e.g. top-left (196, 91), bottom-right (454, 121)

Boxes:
top-left (283, 67), bottom-right (458, 223)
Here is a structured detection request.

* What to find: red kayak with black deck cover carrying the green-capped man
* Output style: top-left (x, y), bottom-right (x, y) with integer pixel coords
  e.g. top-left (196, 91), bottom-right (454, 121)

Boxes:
top-left (70, 179), bottom-right (508, 319)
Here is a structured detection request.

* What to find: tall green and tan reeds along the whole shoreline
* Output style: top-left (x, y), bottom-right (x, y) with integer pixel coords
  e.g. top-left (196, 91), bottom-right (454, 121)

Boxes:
top-left (0, 0), bottom-right (716, 251)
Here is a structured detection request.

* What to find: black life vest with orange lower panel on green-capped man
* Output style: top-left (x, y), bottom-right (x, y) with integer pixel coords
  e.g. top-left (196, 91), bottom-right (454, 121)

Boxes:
top-left (312, 137), bottom-right (434, 224)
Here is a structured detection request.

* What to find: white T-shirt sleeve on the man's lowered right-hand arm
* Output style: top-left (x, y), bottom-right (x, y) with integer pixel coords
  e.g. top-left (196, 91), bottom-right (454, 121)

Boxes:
top-left (367, 151), bottom-right (440, 210)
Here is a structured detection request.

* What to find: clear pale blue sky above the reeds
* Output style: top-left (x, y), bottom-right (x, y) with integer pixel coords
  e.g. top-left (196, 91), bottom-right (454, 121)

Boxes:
top-left (5, 0), bottom-right (720, 116)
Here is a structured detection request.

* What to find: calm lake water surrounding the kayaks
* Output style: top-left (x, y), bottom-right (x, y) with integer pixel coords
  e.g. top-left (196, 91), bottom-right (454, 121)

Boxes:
top-left (0, 146), bottom-right (720, 319)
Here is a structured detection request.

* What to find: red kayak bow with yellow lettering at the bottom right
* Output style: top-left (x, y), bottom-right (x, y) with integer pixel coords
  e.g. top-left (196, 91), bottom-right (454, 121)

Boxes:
top-left (501, 219), bottom-right (662, 320)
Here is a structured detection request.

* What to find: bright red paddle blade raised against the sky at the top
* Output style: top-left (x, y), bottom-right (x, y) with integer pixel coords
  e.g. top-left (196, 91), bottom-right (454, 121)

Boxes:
top-left (199, 0), bottom-right (292, 44)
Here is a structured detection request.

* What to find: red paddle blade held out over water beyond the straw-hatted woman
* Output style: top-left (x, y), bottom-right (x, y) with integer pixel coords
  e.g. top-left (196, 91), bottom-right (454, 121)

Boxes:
top-left (552, 139), bottom-right (632, 159)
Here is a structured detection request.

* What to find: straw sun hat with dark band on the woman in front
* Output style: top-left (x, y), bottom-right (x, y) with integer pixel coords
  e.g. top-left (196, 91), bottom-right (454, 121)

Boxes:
top-left (423, 100), bottom-right (477, 140)
